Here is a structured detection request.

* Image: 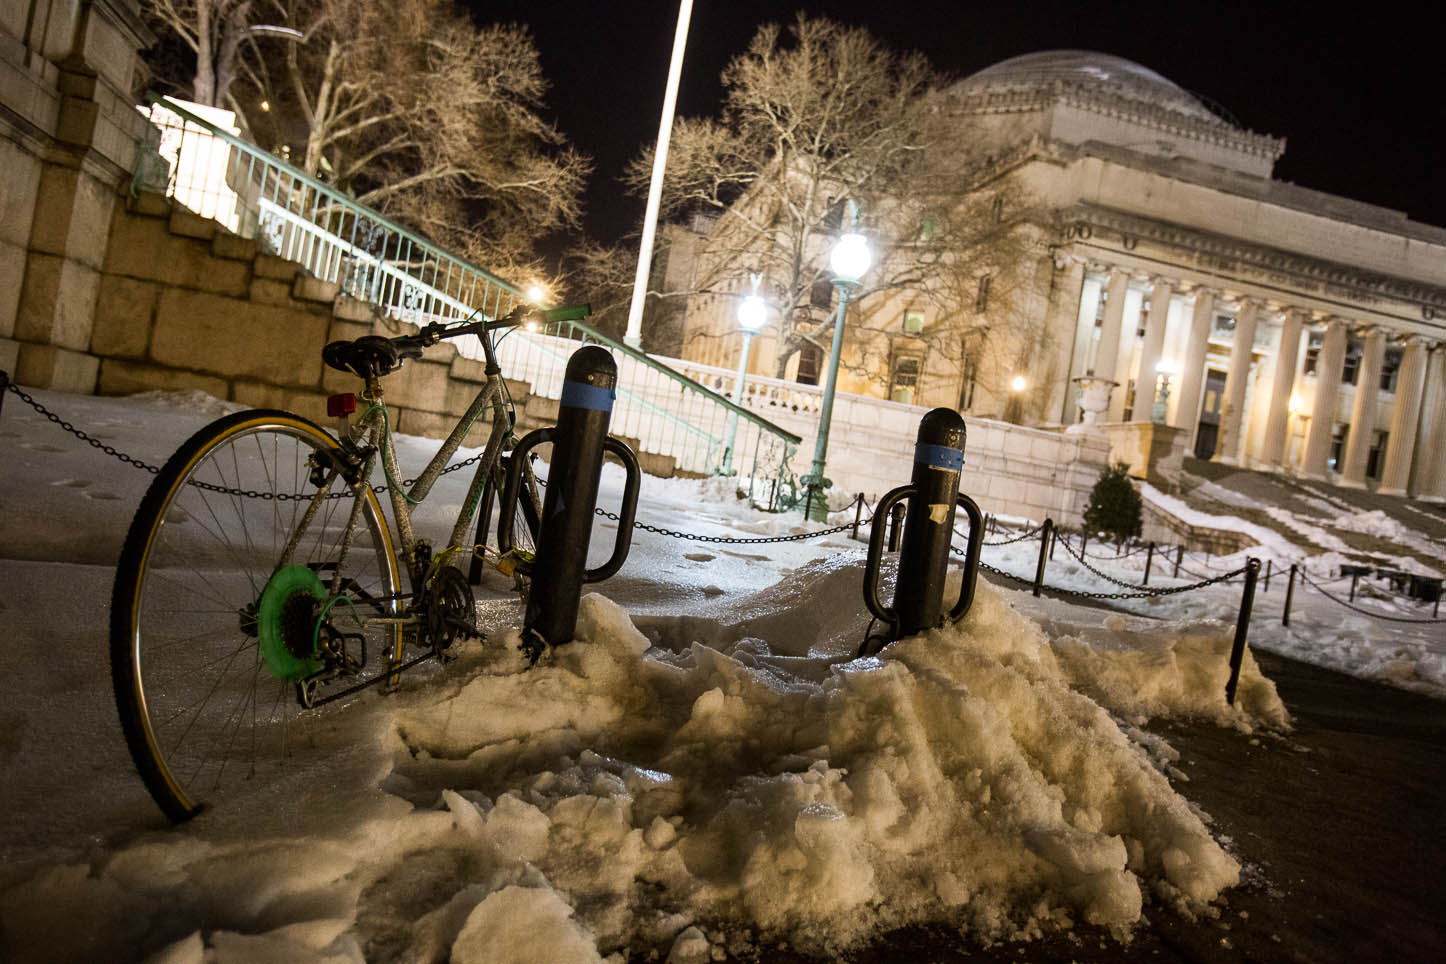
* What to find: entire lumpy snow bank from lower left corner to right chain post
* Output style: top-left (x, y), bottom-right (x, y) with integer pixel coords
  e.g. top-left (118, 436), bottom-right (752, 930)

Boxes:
top-left (0, 565), bottom-right (1284, 961)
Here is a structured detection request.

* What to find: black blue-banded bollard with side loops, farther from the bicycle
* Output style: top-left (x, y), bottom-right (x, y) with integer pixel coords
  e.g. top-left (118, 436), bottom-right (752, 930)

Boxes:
top-left (859, 408), bottom-right (985, 655)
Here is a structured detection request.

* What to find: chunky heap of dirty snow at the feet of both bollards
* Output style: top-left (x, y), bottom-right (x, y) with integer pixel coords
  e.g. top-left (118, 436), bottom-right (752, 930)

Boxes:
top-left (375, 572), bottom-right (1280, 950)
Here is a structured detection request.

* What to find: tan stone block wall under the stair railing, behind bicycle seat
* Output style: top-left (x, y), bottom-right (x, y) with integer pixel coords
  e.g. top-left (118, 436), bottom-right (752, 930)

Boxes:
top-left (65, 194), bottom-right (526, 444)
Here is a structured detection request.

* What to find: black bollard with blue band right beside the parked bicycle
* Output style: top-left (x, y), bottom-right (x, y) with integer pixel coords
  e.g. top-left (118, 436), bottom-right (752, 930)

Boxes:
top-left (497, 345), bottom-right (641, 662)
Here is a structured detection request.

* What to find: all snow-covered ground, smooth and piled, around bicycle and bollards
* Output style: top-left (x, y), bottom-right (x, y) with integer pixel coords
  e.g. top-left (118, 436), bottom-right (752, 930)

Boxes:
top-left (0, 393), bottom-right (1446, 963)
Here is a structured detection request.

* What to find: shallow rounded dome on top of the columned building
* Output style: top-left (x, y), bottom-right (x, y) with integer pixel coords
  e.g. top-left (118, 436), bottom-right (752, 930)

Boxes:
top-left (953, 51), bottom-right (1235, 127)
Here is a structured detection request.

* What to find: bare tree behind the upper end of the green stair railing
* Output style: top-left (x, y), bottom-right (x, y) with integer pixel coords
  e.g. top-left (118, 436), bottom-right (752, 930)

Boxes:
top-left (138, 0), bottom-right (591, 275)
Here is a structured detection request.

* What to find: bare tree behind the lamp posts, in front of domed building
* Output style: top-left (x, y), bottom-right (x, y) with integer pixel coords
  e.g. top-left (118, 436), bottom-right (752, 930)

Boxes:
top-left (628, 14), bottom-right (1025, 404)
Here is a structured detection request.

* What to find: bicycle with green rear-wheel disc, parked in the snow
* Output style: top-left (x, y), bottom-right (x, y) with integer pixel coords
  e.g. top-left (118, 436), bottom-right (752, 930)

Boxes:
top-left (110, 305), bottom-right (589, 822)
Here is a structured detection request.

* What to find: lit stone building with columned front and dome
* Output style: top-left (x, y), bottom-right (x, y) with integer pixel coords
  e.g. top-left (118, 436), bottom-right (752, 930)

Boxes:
top-left (676, 51), bottom-right (1446, 500)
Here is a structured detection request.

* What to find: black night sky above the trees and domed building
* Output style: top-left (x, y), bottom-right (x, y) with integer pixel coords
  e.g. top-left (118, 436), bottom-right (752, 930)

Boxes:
top-left (470, 0), bottom-right (1446, 240)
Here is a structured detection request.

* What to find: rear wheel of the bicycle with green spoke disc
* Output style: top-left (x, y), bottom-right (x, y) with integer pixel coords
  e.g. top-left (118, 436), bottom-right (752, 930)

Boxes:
top-left (110, 409), bottom-right (402, 822)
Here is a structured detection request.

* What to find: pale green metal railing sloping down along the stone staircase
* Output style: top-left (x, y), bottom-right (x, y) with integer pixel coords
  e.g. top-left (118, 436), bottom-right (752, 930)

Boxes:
top-left (134, 95), bottom-right (801, 507)
